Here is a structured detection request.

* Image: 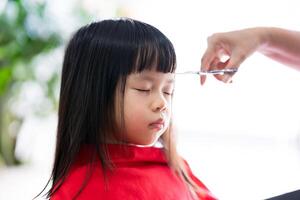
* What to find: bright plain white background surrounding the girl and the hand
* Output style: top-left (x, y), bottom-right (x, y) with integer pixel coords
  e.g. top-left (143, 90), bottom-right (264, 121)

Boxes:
top-left (0, 0), bottom-right (300, 200)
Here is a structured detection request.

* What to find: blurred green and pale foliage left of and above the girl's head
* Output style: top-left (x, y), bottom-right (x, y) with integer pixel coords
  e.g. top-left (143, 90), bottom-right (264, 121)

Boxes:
top-left (0, 0), bottom-right (124, 167)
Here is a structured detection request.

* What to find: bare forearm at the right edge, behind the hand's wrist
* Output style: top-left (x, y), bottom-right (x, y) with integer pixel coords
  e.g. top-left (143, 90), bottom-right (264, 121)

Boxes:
top-left (258, 28), bottom-right (300, 70)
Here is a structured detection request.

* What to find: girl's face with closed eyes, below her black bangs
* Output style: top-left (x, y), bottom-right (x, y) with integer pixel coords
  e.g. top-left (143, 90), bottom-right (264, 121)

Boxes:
top-left (116, 70), bottom-right (175, 145)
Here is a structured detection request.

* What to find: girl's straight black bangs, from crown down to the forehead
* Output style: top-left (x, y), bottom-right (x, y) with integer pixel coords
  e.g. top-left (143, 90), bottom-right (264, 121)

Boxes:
top-left (123, 20), bottom-right (176, 75)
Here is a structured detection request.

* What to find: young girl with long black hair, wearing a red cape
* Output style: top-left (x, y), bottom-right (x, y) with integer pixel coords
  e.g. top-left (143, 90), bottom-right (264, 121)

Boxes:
top-left (41, 19), bottom-right (215, 200)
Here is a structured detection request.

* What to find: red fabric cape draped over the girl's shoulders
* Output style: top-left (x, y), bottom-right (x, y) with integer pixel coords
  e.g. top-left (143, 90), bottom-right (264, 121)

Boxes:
top-left (51, 144), bottom-right (215, 200)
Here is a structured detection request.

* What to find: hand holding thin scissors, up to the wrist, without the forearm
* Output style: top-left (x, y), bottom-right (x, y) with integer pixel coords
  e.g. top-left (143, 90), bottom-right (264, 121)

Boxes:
top-left (201, 28), bottom-right (262, 85)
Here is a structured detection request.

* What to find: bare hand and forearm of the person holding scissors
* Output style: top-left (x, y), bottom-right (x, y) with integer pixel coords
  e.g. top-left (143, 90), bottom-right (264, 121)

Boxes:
top-left (201, 27), bottom-right (300, 85)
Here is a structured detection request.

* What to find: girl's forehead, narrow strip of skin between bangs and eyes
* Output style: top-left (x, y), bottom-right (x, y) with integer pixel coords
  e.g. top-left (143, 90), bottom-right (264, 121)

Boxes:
top-left (128, 70), bottom-right (175, 83)
